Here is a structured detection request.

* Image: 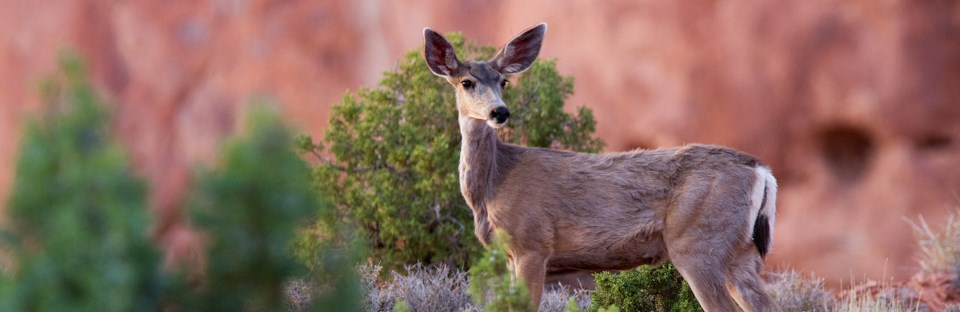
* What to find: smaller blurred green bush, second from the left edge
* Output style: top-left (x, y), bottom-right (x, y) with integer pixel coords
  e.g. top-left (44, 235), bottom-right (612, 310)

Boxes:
top-left (189, 107), bottom-right (359, 311)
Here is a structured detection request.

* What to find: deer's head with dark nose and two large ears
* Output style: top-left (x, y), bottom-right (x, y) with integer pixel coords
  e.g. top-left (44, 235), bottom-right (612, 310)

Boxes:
top-left (423, 23), bottom-right (547, 128)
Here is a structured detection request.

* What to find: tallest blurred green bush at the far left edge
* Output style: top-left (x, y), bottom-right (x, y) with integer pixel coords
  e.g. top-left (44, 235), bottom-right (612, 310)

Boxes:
top-left (0, 56), bottom-right (174, 311)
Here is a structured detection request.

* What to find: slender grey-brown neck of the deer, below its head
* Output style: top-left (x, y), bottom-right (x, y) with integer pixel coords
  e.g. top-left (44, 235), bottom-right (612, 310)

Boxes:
top-left (460, 116), bottom-right (500, 210)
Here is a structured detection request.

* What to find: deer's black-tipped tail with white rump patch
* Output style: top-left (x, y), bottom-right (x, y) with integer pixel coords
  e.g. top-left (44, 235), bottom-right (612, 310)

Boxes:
top-left (747, 165), bottom-right (777, 257)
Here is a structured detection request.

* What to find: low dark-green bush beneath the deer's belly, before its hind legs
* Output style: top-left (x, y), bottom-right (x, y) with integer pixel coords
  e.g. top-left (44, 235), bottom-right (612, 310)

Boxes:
top-left (589, 262), bottom-right (702, 311)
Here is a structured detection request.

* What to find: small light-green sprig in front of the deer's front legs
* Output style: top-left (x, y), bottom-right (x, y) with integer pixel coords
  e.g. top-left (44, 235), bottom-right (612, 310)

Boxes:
top-left (470, 231), bottom-right (537, 311)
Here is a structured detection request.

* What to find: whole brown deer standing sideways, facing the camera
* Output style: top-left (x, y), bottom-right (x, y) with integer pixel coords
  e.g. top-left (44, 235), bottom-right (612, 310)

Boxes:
top-left (423, 24), bottom-right (779, 311)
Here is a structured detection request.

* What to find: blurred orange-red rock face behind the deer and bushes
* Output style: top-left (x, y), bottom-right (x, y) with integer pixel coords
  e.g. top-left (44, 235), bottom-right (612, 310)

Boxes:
top-left (0, 0), bottom-right (960, 285)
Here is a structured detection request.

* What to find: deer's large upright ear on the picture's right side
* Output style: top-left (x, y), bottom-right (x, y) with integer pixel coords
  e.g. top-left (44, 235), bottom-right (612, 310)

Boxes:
top-left (489, 23), bottom-right (547, 74)
